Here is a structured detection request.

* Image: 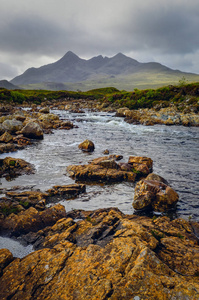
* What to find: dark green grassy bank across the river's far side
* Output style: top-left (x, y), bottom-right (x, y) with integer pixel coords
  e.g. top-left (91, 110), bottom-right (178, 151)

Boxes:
top-left (0, 80), bottom-right (199, 112)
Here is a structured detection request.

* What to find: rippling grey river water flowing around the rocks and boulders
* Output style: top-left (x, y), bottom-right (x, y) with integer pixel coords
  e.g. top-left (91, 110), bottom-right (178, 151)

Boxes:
top-left (0, 111), bottom-right (199, 255)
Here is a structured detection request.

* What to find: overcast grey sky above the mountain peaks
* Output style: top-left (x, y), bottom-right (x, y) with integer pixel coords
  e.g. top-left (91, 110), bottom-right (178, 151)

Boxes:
top-left (0, 0), bottom-right (199, 80)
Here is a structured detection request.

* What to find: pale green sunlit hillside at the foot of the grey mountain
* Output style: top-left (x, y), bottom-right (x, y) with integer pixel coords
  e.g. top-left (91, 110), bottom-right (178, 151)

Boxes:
top-left (20, 71), bottom-right (199, 92)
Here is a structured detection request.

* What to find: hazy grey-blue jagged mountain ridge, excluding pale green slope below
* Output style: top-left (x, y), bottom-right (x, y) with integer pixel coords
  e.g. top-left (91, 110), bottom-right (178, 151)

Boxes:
top-left (10, 51), bottom-right (199, 90)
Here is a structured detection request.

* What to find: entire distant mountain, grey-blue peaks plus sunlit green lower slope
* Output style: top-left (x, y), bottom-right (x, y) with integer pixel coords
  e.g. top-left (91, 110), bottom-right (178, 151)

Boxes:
top-left (11, 51), bottom-right (199, 90)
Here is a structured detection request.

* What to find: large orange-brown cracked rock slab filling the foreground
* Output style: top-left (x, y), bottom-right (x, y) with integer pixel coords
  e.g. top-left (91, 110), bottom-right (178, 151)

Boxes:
top-left (0, 208), bottom-right (199, 300)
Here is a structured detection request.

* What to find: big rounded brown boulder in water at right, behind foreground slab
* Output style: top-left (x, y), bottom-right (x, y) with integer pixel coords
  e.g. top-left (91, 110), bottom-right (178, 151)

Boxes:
top-left (133, 175), bottom-right (179, 212)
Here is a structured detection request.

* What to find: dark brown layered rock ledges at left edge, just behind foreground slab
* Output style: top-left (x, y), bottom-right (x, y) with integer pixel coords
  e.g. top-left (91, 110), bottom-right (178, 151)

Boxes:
top-left (0, 184), bottom-right (86, 236)
